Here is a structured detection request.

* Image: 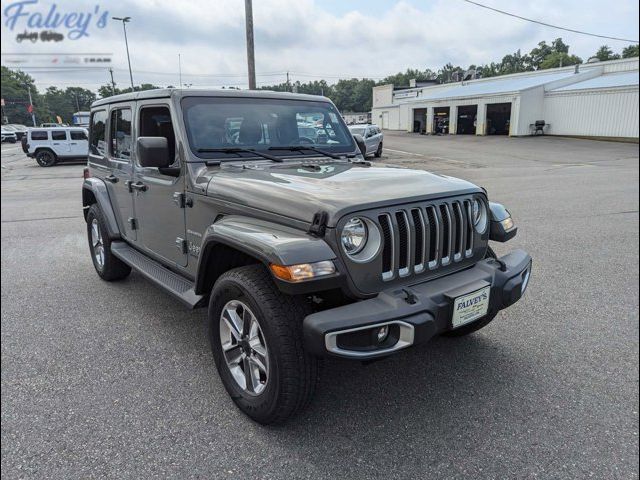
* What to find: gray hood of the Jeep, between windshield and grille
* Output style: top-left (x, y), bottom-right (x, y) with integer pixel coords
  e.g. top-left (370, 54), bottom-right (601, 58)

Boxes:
top-left (207, 162), bottom-right (482, 227)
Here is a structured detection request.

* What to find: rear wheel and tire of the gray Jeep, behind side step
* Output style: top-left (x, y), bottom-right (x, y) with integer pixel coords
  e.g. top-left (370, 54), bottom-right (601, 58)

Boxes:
top-left (87, 203), bottom-right (131, 282)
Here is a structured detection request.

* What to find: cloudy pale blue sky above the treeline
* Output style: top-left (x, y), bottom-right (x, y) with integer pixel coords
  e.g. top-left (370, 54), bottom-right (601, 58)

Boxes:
top-left (1, 0), bottom-right (639, 89)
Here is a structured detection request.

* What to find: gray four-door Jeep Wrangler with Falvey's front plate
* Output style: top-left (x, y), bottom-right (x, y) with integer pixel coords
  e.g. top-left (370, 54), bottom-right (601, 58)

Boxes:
top-left (82, 89), bottom-right (531, 423)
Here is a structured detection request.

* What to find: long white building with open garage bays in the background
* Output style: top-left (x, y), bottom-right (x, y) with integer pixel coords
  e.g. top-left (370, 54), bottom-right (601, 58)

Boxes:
top-left (372, 57), bottom-right (639, 141)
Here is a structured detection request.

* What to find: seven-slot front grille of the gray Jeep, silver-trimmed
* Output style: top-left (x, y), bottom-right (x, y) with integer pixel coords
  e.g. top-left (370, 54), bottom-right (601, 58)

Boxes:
top-left (378, 199), bottom-right (474, 280)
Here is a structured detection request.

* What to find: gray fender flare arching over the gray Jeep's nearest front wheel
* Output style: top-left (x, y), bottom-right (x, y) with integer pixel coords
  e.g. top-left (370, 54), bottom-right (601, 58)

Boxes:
top-left (195, 215), bottom-right (336, 294)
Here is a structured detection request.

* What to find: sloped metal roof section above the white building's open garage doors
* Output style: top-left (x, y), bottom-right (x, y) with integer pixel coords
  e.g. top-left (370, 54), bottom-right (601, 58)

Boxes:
top-left (420, 71), bottom-right (575, 100)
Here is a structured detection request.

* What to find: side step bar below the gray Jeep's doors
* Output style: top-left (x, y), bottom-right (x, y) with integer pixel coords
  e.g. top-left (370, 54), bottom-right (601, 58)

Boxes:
top-left (111, 242), bottom-right (206, 308)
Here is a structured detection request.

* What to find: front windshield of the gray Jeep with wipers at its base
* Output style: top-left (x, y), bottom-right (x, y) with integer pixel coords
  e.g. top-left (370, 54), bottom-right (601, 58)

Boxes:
top-left (182, 97), bottom-right (355, 159)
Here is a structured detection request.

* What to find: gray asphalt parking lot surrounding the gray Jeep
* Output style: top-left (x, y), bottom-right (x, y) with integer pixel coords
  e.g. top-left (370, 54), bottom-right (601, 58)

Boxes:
top-left (1, 134), bottom-right (639, 479)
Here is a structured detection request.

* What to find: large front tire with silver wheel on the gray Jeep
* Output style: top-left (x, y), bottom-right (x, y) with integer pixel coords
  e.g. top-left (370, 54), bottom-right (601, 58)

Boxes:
top-left (209, 265), bottom-right (319, 424)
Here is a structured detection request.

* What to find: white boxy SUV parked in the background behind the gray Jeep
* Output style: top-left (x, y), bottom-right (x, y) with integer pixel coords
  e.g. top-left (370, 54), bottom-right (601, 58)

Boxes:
top-left (22, 127), bottom-right (89, 167)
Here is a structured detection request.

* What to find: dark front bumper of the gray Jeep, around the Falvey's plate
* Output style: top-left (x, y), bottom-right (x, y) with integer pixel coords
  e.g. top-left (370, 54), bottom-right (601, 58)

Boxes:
top-left (303, 250), bottom-right (531, 360)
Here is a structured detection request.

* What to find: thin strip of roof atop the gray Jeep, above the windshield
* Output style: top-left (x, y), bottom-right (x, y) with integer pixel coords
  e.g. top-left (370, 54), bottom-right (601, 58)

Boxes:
top-left (91, 88), bottom-right (330, 108)
